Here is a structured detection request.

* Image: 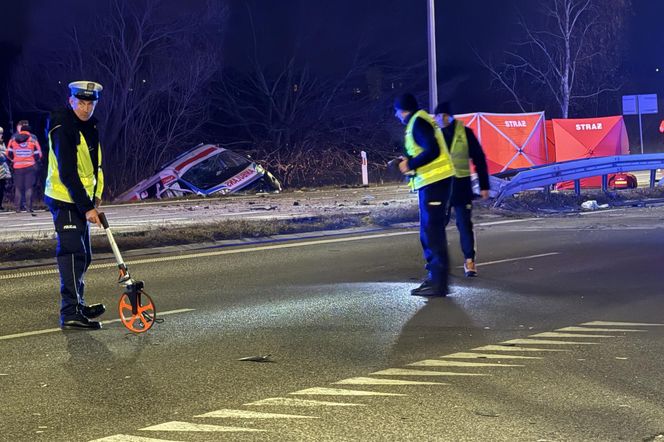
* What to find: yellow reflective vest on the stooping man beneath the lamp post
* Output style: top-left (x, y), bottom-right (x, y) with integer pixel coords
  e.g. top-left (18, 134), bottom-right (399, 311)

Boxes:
top-left (405, 110), bottom-right (454, 189)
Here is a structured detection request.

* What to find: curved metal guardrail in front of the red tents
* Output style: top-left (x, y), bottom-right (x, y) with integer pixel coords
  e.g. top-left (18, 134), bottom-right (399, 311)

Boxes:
top-left (494, 153), bottom-right (664, 206)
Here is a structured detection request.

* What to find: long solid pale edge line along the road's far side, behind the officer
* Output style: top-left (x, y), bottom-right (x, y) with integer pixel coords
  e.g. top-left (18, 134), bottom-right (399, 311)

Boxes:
top-left (0, 231), bottom-right (419, 280)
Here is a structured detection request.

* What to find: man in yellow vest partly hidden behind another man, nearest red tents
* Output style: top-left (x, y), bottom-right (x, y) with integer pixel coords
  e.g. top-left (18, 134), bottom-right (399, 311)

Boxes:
top-left (434, 102), bottom-right (489, 278)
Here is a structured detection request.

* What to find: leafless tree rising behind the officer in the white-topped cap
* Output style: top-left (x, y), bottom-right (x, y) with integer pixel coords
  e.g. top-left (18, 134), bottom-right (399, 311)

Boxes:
top-left (9, 0), bottom-right (226, 194)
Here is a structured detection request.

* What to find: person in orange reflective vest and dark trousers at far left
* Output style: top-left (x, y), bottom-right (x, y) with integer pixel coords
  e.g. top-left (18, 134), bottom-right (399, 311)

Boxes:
top-left (7, 124), bottom-right (42, 213)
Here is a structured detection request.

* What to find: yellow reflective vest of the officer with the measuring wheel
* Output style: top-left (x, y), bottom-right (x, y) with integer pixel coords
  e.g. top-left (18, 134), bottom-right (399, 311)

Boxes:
top-left (44, 126), bottom-right (104, 203)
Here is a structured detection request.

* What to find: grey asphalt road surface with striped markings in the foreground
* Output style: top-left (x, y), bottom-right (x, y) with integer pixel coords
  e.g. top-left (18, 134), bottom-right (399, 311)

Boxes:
top-left (0, 207), bottom-right (664, 442)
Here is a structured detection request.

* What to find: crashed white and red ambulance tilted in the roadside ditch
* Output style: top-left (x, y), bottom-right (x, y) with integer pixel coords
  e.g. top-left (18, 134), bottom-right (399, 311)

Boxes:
top-left (115, 144), bottom-right (281, 202)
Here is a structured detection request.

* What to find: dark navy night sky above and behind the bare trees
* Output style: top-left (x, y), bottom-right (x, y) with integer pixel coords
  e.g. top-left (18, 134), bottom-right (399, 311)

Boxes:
top-left (0, 0), bottom-right (664, 129)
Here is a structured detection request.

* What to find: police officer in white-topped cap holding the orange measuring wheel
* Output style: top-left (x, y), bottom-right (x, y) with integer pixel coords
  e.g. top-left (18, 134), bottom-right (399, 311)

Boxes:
top-left (44, 81), bottom-right (106, 329)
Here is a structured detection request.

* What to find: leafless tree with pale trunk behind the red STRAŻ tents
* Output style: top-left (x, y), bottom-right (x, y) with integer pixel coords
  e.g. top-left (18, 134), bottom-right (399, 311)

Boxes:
top-left (476, 0), bottom-right (631, 118)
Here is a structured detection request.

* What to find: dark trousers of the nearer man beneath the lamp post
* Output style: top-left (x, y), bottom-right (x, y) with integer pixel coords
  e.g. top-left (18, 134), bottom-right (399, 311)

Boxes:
top-left (418, 178), bottom-right (452, 289)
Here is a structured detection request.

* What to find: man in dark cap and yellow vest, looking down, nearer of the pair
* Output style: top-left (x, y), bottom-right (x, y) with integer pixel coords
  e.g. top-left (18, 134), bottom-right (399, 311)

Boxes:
top-left (394, 94), bottom-right (454, 296)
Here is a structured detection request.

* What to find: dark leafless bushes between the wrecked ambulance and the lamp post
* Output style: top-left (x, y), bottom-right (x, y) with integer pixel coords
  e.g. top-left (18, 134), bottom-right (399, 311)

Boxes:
top-left (211, 5), bottom-right (413, 186)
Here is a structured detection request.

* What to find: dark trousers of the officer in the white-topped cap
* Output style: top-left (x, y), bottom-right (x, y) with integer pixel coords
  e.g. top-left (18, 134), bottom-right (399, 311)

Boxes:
top-left (50, 205), bottom-right (92, 321)
